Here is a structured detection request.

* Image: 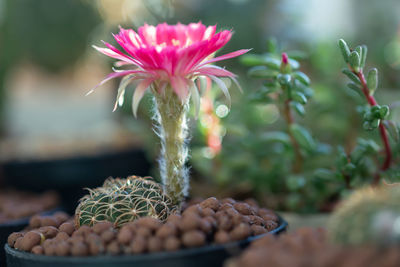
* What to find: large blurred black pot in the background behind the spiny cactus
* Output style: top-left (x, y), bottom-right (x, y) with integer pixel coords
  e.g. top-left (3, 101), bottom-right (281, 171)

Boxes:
top-left (2, 148), bottom-right (150, 213)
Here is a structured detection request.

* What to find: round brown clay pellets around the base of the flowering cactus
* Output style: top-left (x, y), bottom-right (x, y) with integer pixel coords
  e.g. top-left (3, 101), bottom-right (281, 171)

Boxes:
top-left (8, 197), bottom-right (279, 256)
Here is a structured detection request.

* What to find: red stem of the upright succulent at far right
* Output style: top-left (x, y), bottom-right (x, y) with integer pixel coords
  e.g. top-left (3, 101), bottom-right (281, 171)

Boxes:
top-left (352, 70), bottom-right (392, 184)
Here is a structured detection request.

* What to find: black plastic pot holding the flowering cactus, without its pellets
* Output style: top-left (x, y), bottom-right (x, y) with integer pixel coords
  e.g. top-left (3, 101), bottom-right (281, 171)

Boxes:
top-left (5, 218), bottom-right (288, 267)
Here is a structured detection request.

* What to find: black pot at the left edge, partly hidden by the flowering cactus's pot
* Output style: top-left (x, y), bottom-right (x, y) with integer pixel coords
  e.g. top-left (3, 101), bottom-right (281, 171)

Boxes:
top-left (0, 208), bottom-right (61, 267)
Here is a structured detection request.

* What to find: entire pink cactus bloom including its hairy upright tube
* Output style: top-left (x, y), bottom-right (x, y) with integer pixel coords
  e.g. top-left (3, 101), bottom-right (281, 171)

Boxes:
top-left (88, 22), bottom-right (248, 204)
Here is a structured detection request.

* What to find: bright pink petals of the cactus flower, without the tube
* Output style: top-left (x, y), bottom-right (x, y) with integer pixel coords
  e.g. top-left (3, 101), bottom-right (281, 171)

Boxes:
top-left (88, 22), bottom-right (248, 116)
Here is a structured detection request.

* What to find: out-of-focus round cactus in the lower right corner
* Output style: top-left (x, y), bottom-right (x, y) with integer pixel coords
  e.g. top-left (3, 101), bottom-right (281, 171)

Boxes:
top-left (328, 186), bottom-right (400, 245)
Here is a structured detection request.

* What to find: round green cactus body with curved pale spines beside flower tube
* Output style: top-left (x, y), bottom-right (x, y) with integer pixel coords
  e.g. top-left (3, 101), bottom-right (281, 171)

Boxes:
top-left (75, 176), bottom-right (173, 227)
